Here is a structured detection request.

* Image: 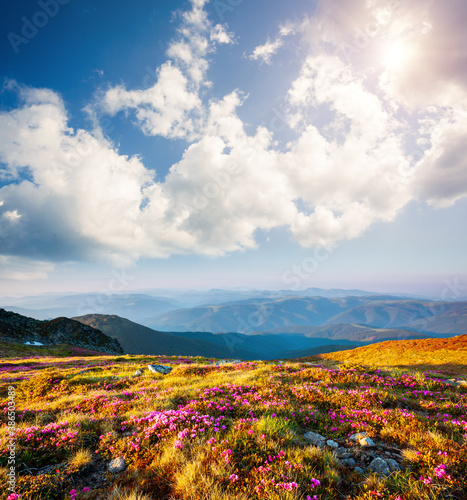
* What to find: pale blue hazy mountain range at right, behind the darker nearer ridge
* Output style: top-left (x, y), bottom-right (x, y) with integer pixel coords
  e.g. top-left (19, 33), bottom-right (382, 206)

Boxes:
top-left (143, 296), bottom-right (467, 334)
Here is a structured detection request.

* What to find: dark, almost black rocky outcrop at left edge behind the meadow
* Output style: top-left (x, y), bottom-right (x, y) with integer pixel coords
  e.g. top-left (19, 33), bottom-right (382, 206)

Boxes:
top-left (0, 309), bottom-right (123, 354)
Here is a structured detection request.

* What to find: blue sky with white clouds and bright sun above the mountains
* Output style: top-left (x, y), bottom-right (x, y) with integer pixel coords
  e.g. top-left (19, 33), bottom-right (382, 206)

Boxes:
top-left (0, 0), bottom-right (467, 296)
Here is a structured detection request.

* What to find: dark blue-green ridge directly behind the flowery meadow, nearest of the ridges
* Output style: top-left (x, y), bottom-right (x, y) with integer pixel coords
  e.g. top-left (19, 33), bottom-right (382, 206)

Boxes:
top-left (74, 314), bottom-right (442, 360)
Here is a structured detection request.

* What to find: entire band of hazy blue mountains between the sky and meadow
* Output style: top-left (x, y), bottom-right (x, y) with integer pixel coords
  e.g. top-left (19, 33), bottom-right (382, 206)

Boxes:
top-left (0, 289), bottom-right (467, 359)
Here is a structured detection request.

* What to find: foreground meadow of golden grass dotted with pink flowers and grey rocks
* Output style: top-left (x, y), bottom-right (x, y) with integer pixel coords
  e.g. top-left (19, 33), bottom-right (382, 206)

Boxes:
top-left (0, 341), bottom-right (467, 500)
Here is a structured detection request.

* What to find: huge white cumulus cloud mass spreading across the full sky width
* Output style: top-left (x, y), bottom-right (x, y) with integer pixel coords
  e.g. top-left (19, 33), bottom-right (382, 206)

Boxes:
top-left (0, 0), bottom-right (467, 278)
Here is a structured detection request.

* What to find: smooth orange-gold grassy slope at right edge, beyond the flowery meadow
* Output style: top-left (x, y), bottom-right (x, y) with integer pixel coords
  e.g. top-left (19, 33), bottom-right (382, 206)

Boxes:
top-left (320, 335), bottom-right (467, 374)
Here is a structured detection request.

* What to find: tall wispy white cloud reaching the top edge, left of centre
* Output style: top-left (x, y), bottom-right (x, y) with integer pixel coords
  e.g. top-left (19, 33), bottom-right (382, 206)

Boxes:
top-left (99, 1), bottom-right (215, 139)
